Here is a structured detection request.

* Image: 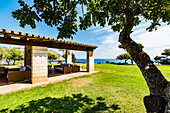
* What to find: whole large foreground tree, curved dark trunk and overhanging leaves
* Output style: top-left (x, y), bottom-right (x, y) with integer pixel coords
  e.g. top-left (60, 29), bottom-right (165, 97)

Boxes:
top-left (12, 0), bottom-right (170, 112)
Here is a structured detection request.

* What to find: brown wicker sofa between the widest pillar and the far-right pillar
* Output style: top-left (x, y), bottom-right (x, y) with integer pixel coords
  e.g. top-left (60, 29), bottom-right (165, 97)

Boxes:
top-left (54, 64), bottom-right (80, 74)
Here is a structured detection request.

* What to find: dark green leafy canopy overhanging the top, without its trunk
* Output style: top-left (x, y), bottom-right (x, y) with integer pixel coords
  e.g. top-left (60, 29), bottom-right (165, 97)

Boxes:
top-left (12, 0), bottom-right (170, 38)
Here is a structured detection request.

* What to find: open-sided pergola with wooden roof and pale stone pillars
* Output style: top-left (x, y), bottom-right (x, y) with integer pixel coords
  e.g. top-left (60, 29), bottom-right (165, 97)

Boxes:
top-left (0, 29), bottom-right (97, 83)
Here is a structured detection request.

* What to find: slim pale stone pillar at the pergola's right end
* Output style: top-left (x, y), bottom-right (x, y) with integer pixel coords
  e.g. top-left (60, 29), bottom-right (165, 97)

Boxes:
top-left (87, 51), bottom-right (94, 72)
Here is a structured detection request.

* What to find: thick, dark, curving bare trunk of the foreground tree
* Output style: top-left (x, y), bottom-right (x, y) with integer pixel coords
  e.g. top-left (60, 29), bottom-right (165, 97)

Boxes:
top-left (119, 9), bottom-right (170, 113)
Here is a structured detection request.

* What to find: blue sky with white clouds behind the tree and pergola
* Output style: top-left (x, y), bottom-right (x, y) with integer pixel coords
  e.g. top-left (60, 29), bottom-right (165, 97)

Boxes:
top-left (0, 0), bottom-right (170, 59)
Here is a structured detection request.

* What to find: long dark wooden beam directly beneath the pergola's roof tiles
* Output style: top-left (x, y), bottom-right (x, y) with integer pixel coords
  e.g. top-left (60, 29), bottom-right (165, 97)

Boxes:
top-left (0, 37), bottom-right (97, 51)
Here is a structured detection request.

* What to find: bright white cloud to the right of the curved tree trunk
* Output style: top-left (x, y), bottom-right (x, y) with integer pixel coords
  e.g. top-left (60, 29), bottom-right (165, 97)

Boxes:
top-left (133, 26), bottom-right (170, 58)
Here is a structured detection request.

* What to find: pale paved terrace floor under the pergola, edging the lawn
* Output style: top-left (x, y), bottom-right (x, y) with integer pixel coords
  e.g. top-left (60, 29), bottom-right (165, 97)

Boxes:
top-left (0, 70), bottom-right (98, 94)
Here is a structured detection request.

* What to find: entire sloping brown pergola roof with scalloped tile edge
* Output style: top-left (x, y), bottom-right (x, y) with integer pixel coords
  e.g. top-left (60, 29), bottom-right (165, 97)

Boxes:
top-left (0, 29), bottom-right (97, 51)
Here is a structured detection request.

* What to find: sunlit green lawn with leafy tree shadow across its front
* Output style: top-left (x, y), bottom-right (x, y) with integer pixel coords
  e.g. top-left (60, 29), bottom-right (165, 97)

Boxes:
top-left (0, 64), bottom-right (170, 113)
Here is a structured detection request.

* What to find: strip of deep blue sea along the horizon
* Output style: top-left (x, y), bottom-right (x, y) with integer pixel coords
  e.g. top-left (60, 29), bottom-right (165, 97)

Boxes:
top-left (49, 59), bottom-right (131, 64)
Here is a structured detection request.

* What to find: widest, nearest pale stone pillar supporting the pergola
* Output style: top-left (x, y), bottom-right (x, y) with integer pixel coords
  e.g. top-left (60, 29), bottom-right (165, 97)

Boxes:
top-left (25, 46), bottom-right (48, 84)
